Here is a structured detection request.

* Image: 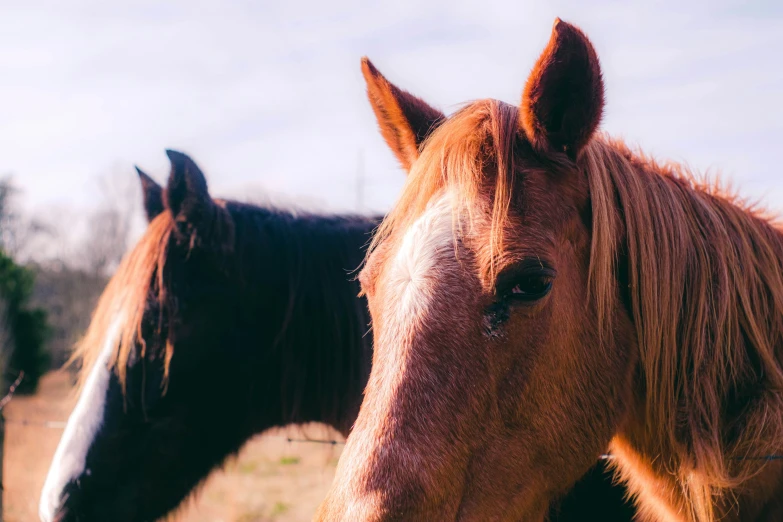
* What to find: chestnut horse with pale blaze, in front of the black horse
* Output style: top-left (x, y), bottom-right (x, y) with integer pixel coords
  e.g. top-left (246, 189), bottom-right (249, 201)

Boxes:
top-left (319, 20), bottom-right (783, 522)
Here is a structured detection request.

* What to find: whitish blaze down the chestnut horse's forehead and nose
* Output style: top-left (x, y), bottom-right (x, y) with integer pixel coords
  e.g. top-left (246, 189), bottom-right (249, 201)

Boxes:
top-left (337, 192), bottom-right (460, 500)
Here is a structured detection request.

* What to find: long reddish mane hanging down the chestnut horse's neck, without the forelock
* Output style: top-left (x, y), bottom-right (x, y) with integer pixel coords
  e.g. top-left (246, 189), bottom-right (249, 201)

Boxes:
top-left (582, 138), bottom-right (783, 520)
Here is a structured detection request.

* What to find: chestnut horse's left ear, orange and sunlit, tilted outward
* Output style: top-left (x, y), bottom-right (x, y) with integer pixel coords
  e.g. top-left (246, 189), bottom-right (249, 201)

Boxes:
top-left (362, 57), bottom-right (446, 171)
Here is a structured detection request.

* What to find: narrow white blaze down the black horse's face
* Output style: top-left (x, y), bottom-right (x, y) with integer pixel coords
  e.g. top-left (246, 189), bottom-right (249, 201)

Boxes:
top-left (38, 317), bottom-right (122, 522)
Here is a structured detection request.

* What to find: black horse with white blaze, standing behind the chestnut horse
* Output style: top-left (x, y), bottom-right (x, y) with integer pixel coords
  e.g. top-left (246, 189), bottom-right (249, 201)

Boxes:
top-left (40, 152), bottom-right (630, 522)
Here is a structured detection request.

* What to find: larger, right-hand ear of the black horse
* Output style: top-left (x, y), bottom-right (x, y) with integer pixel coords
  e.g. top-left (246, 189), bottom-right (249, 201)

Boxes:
top-left (165, 150), bottom-right (216, 238)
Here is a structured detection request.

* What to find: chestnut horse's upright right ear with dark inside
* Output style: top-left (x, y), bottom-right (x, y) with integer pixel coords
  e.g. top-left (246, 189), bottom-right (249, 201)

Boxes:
top-left (520, 18), bottom-right (604, 159)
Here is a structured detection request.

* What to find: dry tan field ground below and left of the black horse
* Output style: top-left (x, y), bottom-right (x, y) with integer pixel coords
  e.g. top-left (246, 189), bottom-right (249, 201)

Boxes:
top-left (3, 373), bottom-right (341, 522)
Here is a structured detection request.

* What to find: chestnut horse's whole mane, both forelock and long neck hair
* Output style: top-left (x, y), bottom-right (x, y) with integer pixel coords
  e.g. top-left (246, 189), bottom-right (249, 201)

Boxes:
top-left (372, 100), bottom-right (783, 521)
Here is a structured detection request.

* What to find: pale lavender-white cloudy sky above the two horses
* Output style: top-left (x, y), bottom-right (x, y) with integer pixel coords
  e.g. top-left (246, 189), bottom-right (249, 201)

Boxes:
top-left (0, 0), bottom-right (783, 217)
